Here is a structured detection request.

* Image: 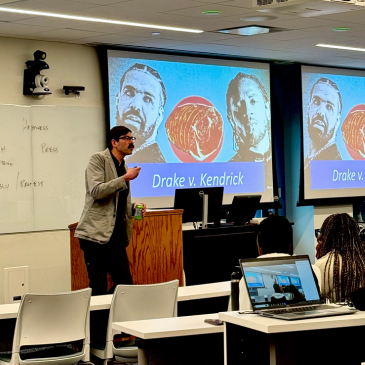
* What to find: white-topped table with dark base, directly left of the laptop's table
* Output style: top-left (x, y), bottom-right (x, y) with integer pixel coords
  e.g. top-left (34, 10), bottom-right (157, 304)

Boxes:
top-left (112, 313), bottom-right (224, 365)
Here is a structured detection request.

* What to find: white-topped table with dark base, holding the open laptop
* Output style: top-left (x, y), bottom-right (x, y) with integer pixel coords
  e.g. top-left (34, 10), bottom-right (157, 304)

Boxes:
top-left (219, 312), bottom-right (365, 365)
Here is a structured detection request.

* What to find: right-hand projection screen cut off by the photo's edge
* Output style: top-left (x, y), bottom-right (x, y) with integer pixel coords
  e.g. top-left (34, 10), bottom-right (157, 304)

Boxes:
top-left (302, 66), bottom-right (365, 199)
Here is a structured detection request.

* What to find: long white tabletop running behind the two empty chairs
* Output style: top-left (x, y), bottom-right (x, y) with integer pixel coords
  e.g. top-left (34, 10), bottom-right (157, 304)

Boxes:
top-left (0, 281), bottom-right (231, 319)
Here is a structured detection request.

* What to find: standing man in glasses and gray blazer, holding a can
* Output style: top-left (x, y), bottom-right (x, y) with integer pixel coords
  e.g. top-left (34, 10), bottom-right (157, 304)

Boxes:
top-left (75, 126), bottom-right (146, 295)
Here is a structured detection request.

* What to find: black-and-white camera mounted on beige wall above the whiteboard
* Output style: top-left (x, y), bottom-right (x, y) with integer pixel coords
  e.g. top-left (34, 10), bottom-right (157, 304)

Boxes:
top-left (23, 50), bottom-right (52, 96)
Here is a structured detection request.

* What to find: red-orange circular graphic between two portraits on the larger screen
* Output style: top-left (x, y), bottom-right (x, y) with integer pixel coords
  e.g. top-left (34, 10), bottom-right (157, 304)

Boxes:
top-left (165, 96), bottom-right (223, 162)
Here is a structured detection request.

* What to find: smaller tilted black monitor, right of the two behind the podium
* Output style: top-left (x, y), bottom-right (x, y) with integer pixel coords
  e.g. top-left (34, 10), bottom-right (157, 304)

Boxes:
top-left (227, 195), bottom-right (261, 225)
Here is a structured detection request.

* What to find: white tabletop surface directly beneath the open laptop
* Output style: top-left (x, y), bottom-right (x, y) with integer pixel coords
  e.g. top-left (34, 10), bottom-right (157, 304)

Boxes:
top-left (219, 312), bottom-right (365, 333)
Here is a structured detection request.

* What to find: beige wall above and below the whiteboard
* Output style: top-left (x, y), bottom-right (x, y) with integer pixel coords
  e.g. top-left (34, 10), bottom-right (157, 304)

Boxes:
top-left (0, 38), bottom-right (105, 303)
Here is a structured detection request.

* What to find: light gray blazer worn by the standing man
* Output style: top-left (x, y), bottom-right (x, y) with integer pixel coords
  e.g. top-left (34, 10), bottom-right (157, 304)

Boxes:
top-left (75, 148), bottom-right (132, 247)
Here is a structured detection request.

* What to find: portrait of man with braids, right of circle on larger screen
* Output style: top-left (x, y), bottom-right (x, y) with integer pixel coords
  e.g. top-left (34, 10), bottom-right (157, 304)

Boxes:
top-left (226, 72), bottom-right (272, 189)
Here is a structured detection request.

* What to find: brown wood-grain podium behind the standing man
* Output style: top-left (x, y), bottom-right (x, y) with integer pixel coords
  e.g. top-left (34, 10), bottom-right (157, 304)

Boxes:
top-left (68, 209), bottom-right (184, 290)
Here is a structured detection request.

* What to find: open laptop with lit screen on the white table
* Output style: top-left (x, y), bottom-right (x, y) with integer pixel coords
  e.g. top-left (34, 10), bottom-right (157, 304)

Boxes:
top-left (240, 255), bottom-right (356, 320)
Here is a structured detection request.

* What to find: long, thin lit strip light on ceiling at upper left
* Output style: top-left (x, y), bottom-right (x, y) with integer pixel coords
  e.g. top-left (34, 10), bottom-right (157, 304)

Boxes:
top-left (0, 7), bottom-right (204, 33)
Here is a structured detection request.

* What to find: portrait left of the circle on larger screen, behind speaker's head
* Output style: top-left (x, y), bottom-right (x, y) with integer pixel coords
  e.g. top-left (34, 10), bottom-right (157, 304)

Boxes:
top-left (117, 63), bottom-right (166, 163)
